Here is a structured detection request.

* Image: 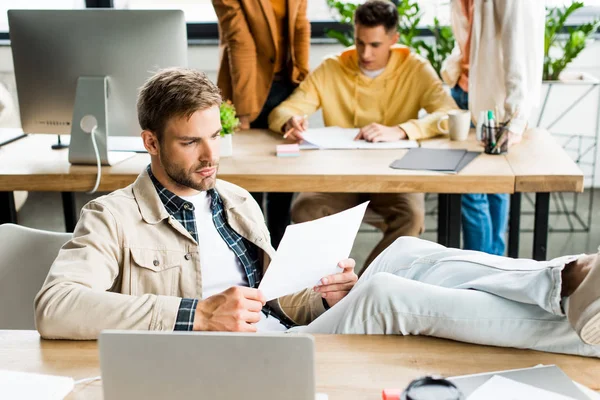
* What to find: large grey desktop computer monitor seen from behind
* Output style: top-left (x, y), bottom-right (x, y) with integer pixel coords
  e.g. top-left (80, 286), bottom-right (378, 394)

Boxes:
top-left (8, 9), bottom-right (187, 164)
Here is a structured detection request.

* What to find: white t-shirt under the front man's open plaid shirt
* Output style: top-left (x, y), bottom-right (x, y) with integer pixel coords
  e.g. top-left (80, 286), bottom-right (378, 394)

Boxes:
top-left (181, 191), bottom-right (287, 331)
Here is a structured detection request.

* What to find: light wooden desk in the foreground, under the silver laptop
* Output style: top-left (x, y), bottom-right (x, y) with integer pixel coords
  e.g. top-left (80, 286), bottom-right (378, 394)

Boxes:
top-left (0, 331), bottom-right (600, 400)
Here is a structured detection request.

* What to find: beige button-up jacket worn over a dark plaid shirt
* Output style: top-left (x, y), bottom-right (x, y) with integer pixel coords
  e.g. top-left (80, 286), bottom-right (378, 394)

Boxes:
top-left (35, 171), bottom-right (325, 339)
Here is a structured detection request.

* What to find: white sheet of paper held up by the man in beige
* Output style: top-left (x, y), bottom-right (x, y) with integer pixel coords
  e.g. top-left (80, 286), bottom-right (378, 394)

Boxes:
top-left (258, 201), bottom-right (369, 301)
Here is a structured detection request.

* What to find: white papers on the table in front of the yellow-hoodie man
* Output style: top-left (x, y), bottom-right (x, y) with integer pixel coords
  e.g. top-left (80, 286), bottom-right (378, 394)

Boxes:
top-left (301, 126), bottom-right (419, 149)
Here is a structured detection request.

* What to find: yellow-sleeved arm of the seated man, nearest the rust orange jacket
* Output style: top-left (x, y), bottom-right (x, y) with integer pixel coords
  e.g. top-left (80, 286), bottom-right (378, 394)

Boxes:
top-left (269, 63), bottom-right (325, 133)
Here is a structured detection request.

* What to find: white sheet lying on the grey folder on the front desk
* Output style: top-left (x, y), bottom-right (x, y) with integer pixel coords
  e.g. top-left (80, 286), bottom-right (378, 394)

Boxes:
top-left (468, 375), bottom-right (573, 400)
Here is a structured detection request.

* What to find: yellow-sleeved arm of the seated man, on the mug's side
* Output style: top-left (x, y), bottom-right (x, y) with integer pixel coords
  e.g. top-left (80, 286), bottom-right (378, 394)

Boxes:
top-left (399, 62), bottom-right (458, 140)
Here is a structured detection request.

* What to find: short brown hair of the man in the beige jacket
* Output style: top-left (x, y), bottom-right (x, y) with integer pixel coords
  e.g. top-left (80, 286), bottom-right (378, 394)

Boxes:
top-left (137, 68), bottom-right (222, 141)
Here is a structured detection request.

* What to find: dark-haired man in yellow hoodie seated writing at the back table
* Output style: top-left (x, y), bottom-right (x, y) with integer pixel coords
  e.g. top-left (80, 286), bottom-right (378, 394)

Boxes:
top-left (269, 0), bottom-right (457, 267)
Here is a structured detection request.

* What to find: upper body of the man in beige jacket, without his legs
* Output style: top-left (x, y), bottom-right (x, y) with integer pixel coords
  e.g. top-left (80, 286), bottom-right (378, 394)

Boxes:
top-left (35, 69), bottom-right (357, 339)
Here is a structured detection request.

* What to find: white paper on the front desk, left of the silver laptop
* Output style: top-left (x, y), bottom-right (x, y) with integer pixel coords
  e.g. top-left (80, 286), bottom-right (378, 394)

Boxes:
top-left (0, 370), bottom-right (75, 400)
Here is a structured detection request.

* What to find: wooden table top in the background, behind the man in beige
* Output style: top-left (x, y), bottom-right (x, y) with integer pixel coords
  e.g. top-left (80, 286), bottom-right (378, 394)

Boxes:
top-left (0, 130), bottom-right (583, 193)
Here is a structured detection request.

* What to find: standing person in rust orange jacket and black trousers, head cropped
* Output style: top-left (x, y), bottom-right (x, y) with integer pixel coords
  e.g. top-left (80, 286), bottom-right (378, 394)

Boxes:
top-left (212, 0), bottom-right (310, 248)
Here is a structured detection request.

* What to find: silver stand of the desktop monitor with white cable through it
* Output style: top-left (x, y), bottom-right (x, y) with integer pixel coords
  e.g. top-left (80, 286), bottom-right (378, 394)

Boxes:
top-left (69, 76), bottom-right (135, 165)
